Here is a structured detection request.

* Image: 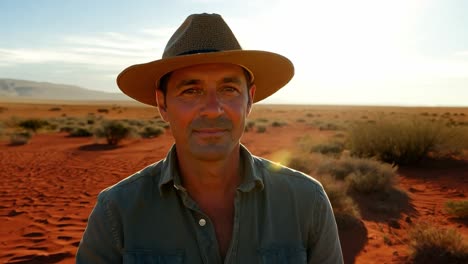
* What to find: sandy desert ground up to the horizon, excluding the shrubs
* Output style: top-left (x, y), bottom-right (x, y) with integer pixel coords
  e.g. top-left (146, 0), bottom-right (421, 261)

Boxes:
top-left (0, 101), bottom-right (468, 264)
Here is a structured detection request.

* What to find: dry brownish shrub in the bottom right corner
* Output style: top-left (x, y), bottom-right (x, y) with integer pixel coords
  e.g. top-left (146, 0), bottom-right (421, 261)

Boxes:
top-left (409, 223), bottom-right (468, 264)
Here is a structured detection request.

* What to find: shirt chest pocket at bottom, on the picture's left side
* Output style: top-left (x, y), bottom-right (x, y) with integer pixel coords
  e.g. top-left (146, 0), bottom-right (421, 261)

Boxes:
top-left (123, 251), bottom-right (184, 264)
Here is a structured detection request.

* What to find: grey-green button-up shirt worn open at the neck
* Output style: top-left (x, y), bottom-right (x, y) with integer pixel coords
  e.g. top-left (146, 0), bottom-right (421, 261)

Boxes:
top-left (76, 146), bottom-right (343, 264)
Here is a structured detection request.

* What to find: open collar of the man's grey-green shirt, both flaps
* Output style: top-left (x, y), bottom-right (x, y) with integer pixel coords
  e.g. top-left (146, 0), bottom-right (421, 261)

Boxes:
top-left (158, 144), bottom-right (264, 194)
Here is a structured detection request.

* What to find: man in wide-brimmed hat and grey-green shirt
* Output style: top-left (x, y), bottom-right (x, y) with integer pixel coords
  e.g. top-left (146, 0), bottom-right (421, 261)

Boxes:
top-left (76, 14), bottom-right (343, 263)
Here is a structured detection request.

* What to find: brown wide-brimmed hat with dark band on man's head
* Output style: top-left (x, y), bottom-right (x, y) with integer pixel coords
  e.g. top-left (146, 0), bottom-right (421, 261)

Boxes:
top-left (117, 14), bottom-right (294, 106)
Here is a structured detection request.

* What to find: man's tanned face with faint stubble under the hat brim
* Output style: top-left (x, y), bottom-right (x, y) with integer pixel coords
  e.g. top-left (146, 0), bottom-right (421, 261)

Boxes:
top-left (157, 64), bottom-right (255, 161)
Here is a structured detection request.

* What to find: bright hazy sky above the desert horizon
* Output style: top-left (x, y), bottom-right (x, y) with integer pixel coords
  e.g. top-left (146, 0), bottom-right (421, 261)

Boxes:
top-left (0, 0), bottom-right (468, 106)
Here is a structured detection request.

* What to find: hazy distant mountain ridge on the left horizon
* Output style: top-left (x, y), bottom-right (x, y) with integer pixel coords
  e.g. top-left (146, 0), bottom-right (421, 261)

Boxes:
top-left (0, 79), bottom-right (129, 101)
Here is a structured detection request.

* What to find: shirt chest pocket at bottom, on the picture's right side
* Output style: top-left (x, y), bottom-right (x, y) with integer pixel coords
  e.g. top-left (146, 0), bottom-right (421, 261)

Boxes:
top-left (259, 246), bottom-right (307, 264)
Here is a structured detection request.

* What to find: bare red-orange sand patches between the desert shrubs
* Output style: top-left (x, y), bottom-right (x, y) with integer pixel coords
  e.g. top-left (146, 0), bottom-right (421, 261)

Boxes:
top-left (0, 102), bottom-right (468, 263)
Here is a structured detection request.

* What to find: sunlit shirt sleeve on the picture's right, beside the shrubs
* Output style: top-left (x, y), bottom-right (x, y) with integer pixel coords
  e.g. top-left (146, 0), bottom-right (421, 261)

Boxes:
top-left (307, 188), bottom-right (343, 264)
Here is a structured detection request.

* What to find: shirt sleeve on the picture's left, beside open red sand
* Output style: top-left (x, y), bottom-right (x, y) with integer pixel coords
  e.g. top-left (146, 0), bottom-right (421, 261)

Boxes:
top-left (76, 193), bottom-right (122, 264)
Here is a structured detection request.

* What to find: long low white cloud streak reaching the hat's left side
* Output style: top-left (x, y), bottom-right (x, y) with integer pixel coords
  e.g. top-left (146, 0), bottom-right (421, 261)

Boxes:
top-left (0, 29), bottom-right (167, 69)
